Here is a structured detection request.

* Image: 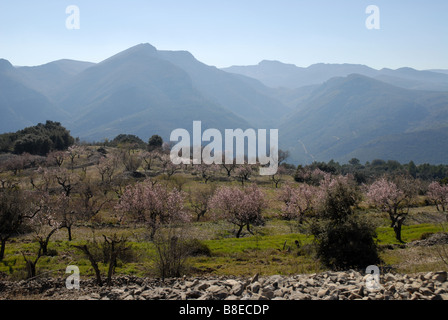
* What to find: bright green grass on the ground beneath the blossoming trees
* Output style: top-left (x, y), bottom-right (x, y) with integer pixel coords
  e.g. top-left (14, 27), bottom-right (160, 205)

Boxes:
top-left (0, 216), bottom-right (446, 280)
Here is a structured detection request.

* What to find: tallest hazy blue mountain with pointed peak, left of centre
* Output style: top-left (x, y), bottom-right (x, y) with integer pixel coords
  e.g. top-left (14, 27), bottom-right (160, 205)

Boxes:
top-left (52, 45), bottom-right (256, 140)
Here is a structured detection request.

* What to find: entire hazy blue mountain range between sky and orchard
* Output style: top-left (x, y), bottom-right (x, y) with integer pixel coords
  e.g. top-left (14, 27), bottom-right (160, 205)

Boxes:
top-left (0, 44), bottom-right (448, 164)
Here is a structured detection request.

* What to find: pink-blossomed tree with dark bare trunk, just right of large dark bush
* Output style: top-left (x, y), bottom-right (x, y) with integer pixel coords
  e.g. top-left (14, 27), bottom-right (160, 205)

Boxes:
top-left (367, 178), bottom-right (415, 242)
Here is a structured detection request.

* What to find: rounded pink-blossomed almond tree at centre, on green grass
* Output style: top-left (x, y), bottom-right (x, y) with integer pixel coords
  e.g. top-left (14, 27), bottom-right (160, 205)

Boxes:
top-left (210, 184), bottom-right (267, 238)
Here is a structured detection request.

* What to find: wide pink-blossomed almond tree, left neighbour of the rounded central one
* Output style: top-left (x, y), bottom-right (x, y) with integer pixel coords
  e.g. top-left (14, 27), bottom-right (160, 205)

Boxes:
top-left (116, 181), bottom-right (190, 240)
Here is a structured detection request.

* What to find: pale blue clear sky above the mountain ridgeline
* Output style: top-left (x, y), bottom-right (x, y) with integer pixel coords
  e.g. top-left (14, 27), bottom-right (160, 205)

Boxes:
top-left (0, 0), bottom-right (448, 70)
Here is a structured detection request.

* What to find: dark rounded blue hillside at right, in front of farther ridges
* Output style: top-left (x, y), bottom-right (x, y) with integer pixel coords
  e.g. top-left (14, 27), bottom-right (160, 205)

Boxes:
top-left (280, 75), bottom-right (448, 163)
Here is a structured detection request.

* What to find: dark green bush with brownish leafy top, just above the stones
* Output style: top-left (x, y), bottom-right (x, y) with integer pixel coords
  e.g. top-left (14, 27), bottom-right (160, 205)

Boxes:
top-left (311, 177), bottom-right (379, 270)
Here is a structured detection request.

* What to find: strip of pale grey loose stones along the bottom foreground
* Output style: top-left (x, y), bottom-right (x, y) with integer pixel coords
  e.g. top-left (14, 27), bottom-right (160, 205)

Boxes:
top-left (0, 270), bottom-right (448, 300)
